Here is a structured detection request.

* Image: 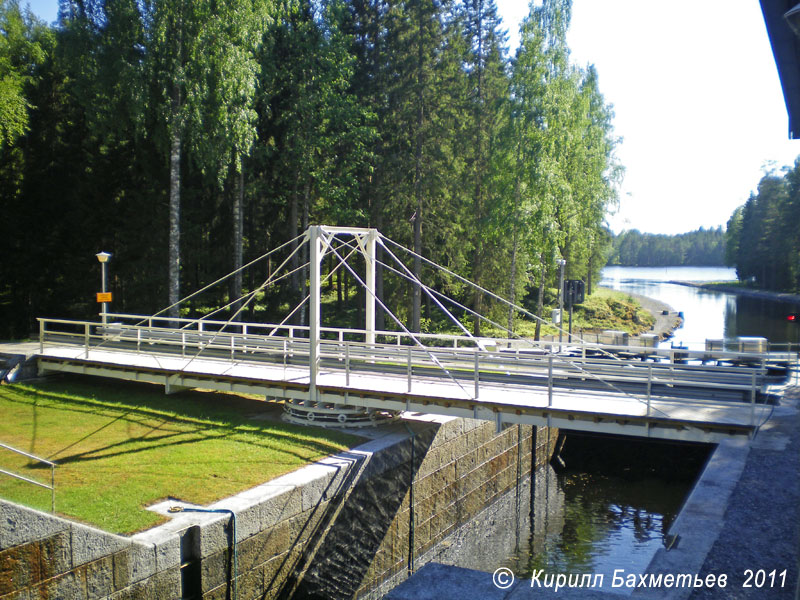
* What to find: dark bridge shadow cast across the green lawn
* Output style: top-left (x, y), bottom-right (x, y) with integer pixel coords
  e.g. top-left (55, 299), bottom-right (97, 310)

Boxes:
top-left (0, 376), bottom-right (358, 465)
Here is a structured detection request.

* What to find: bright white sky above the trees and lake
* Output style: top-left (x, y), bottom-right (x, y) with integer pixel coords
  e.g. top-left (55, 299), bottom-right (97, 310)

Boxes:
top-left (21, 0), bottom-right (800, 234)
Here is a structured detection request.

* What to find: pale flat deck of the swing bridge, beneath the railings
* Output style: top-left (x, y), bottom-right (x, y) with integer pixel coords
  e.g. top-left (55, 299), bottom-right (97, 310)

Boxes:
top-left (34, 346), bottom-right (771, 442)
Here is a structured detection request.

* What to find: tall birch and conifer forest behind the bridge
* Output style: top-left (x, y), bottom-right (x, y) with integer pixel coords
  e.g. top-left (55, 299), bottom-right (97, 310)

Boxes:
top-left (0, 0), bottom-right (623, 339)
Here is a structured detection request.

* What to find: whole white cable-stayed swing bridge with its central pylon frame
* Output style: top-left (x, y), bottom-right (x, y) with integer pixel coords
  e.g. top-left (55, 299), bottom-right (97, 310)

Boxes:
top-left (32, 226), bottom-right (796, 442)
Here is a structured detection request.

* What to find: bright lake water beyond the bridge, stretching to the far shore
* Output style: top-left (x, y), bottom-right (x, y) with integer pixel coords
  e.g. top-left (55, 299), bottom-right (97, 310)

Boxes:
top-left (600, 267), bottom-right (800, 349)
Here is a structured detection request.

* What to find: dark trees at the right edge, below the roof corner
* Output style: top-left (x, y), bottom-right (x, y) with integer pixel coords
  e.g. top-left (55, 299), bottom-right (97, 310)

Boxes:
top-left (725, 159), bottom-right (800, 293)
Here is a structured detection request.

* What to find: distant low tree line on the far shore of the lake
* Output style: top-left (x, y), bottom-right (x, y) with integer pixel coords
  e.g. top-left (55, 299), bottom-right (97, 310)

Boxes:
top-left (608, 227), bottom-right (725, 267)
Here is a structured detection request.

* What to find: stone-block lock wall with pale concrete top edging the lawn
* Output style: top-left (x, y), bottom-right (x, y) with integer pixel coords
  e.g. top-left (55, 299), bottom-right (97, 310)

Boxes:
top-left (0, 419), bottom-right (557, 600)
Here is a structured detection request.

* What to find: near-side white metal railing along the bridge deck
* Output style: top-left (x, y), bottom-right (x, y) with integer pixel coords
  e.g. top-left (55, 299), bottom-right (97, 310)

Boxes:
top-left (39, 315), bottom-right (780, 420)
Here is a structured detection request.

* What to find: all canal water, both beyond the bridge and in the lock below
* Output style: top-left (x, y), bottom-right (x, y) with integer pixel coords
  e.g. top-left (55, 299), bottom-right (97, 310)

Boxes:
top-left (468, 267), bottom-right (800, 593)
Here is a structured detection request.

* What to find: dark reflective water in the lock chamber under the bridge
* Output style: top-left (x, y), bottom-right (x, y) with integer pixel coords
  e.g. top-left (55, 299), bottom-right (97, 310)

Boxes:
top-left (490, 432), bottom-right (709, 593)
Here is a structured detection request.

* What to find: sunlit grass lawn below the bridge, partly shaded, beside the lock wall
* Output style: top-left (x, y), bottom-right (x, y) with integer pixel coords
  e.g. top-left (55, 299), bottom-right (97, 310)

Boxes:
top-left (0, 377), bottom-right (360, 533)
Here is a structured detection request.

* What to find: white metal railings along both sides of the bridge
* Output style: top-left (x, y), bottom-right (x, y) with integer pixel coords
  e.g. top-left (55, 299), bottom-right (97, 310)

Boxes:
top-left (39, 314), bottom-right (797, 416)
